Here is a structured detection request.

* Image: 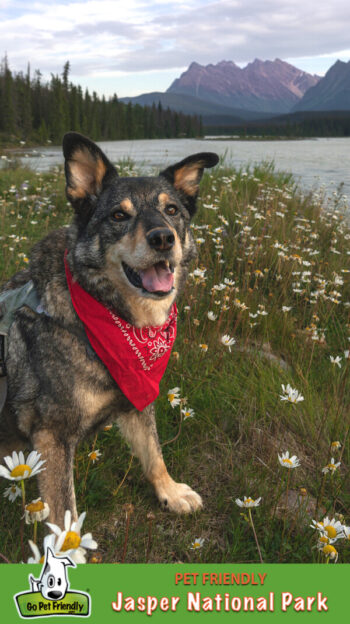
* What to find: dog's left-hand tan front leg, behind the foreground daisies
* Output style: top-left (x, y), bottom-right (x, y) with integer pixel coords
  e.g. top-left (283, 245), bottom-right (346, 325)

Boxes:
top-left (32, 430), bottom-right (78, 529)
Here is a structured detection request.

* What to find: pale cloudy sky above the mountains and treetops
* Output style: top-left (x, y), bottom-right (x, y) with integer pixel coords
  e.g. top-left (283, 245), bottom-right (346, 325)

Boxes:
top-left (0, 0), bottom-right (350, 97)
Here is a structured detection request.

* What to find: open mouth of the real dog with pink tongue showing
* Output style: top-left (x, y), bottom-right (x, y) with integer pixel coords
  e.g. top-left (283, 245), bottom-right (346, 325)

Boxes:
top-left (122, 260), bottom-right (174, 297)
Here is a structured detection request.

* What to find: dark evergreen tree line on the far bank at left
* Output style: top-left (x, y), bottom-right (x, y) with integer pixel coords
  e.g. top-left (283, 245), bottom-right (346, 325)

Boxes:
top-left (0, 57), bottom-right (203, 143)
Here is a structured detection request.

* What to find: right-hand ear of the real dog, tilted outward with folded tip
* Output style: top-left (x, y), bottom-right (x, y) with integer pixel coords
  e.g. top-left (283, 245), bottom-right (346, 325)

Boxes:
top-left (159, 152), bottom-right (219, 215)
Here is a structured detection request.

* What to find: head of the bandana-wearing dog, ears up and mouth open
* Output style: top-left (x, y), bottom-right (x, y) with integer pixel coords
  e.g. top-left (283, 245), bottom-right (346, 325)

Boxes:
top-left (63, 132), bottom-right (218, 327)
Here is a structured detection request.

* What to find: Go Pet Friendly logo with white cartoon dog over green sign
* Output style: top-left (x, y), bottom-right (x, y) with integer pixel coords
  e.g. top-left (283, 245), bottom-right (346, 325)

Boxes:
top-left (14, 547), bottom-right (91, 618)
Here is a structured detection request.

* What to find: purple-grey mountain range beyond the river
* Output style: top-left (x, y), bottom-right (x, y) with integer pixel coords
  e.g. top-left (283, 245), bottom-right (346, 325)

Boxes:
top-left (121, 59), bottom-right (350, 125)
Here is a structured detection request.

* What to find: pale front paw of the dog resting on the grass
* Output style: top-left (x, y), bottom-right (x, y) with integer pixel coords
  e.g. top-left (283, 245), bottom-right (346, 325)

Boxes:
top-left (156, 477), bottom-right (203, 514)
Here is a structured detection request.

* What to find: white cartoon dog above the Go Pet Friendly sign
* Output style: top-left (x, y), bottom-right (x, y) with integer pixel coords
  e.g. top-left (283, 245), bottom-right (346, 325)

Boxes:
top-left (29, 546), bottom-right (76, 600)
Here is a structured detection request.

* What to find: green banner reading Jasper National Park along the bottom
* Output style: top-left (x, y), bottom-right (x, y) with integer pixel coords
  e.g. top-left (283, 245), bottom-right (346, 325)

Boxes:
top-left (0, 564), bottom-right (349, 624)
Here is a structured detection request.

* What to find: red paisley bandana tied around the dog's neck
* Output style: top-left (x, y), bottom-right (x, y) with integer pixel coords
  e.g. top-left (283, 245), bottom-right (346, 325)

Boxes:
top-left (64, 251), bottom-right (177, 411)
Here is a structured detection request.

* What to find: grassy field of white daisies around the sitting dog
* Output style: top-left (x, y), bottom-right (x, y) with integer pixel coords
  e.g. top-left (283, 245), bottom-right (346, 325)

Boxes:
top-left (0, 156), bottom-right (350, 563)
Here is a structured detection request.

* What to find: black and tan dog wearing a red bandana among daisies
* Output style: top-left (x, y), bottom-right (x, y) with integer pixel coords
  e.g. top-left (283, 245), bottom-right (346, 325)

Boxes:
top-left (0, 132), bottom-right (218, 526)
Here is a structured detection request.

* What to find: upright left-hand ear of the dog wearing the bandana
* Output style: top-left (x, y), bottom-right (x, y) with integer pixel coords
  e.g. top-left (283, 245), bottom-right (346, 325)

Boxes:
top-left (63, 132), bottom-right (118, 211)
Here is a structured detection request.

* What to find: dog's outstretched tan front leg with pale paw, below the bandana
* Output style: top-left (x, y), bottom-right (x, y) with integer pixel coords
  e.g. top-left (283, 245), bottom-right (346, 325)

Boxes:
top-left (117, 406), bottom-right (202, 513)
